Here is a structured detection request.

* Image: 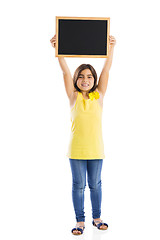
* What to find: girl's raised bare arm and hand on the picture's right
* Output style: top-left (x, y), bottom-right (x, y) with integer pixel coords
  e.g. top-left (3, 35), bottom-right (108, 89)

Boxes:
top-left (97, 36), bottom-right (116, 96)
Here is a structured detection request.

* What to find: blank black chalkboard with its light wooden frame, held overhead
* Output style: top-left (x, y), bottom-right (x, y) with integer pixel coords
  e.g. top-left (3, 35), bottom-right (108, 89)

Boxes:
top-left (55, 16), bottom-right (110, 58)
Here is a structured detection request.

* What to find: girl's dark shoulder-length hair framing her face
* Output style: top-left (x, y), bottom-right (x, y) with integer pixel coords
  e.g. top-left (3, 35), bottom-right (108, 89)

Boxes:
top-left (73, 64), bottom-right (98, 93)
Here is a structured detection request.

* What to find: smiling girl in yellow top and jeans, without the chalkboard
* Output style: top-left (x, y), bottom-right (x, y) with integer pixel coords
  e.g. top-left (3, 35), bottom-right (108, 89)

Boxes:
top-left (50, 32), bottom-right (116, 235)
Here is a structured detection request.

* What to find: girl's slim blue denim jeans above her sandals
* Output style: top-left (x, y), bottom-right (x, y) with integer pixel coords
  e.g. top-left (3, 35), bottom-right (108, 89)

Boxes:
top-left (69, 158), bottom-right (103, 222)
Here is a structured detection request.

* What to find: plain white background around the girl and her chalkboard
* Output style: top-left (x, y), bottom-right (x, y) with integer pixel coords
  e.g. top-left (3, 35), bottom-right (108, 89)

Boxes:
top-left (0, 0), bottom-right (160, 240)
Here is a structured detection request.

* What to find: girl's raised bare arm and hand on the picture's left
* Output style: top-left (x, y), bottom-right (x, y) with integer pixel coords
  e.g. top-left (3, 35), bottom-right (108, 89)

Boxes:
top-left (50, 35), bottom-right (74, 99)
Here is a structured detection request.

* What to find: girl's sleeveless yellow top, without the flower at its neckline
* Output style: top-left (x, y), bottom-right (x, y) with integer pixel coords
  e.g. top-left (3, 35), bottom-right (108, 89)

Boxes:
top-left (67, 92), bottom-right (105, 159)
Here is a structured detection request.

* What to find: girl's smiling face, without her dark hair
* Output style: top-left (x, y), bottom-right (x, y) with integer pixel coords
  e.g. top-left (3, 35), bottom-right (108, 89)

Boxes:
top-left (77, 69), bottom-right (94, 92)
